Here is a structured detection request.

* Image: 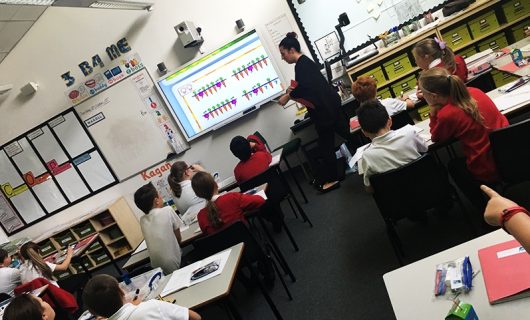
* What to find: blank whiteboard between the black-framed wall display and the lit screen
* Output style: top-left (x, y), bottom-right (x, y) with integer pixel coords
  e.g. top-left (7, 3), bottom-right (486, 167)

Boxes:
top-left (75, 69), bottom-right (187, 181)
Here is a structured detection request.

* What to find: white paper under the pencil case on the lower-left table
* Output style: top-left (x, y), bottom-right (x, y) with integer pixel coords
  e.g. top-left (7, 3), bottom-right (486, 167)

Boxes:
top-left (160, 249), bottom-right (232, 297)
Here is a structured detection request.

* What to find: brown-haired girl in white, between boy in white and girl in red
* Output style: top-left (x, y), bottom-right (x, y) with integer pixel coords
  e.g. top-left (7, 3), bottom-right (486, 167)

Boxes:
top-left (167, 161), bottom-right (204, 216)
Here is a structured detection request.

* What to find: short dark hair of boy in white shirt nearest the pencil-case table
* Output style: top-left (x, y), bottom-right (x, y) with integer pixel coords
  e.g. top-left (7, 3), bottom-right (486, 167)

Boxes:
top-left (83, 274), bottom-right (123, 318)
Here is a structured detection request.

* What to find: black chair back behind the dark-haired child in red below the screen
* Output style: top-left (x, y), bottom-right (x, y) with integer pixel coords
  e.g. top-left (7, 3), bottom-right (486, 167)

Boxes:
top-left (239, 167), bottom-right (289, 202)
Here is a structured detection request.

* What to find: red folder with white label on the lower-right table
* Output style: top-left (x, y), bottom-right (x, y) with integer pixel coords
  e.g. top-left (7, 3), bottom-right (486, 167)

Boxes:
top-left (478, 240), bottom-right (530, 304)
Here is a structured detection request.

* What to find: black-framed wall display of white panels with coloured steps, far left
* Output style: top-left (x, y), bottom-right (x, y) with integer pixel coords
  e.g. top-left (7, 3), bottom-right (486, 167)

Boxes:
top-left (0, 109), bottom-right (117, 235)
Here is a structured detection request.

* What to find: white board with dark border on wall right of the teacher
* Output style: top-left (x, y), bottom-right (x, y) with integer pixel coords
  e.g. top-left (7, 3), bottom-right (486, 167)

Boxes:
top-left (288, 0), bottom-right (445, 63)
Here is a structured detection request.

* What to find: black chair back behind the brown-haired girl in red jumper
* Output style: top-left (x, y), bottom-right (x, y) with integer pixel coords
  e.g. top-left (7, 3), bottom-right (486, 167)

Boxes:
top-left (193, 221), bottom-right (266, 263)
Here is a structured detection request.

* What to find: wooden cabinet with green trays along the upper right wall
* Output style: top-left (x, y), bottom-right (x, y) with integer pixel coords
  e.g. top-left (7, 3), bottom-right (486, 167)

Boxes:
top-left (347, 0), bottom-right (530, 101)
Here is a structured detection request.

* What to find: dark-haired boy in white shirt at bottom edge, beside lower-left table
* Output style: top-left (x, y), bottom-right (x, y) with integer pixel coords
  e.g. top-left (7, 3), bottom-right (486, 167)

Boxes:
top-left (83, 274), bottom-right (201, 320)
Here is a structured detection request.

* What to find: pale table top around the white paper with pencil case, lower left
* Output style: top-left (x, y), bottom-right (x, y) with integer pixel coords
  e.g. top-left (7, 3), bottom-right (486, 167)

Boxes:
top-left (153, 243), bottom-right (244, 308)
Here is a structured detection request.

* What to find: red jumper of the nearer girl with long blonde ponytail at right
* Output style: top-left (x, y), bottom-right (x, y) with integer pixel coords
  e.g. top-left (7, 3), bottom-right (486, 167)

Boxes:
top-left (429, 88), bottom-right (509, 182)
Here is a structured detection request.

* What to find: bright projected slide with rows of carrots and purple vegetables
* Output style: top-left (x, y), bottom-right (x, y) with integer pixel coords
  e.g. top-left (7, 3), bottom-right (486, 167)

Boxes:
top-left (158, 30), bottom-right (283, 140)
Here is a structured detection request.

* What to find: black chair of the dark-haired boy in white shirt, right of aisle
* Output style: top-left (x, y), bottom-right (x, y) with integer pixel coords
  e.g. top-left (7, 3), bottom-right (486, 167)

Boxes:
top-left (370, 154), bottom-right (474, 265)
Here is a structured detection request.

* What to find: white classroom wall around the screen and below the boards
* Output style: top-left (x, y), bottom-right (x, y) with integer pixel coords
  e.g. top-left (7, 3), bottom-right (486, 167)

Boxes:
top-left (0, 0), bottom-right (310, 242)
